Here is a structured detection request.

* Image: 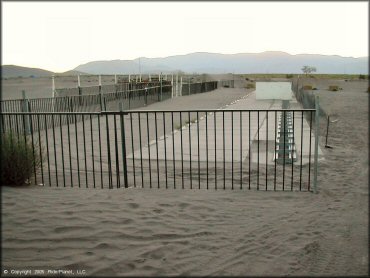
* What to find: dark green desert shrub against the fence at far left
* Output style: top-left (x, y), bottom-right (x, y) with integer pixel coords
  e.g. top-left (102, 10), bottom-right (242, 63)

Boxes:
top-left (0, 132), bottom-right (41, 185)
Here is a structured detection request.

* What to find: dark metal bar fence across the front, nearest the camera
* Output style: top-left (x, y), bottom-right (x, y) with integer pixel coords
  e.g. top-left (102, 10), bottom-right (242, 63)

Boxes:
top-left (0, 109), bottom-right (315, 191)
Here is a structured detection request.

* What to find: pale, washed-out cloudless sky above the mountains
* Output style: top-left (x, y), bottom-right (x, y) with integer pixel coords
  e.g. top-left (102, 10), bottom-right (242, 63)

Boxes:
top-left (1, 1), bottom-right (369, 72)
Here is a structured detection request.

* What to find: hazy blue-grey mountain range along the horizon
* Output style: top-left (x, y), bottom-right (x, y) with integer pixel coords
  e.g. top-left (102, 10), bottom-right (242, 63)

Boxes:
top-left (2, 51), bottom-right (369, 78)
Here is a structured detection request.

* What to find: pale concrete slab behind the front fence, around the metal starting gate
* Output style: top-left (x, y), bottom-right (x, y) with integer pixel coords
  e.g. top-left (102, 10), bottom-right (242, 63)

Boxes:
top-left (128, 92), bottom-right (323, 164)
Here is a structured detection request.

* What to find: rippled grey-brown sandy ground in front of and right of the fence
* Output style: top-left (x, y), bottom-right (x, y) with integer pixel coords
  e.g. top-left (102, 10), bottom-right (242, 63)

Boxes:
top-left (2, 76), bottom-right (369, 276)
